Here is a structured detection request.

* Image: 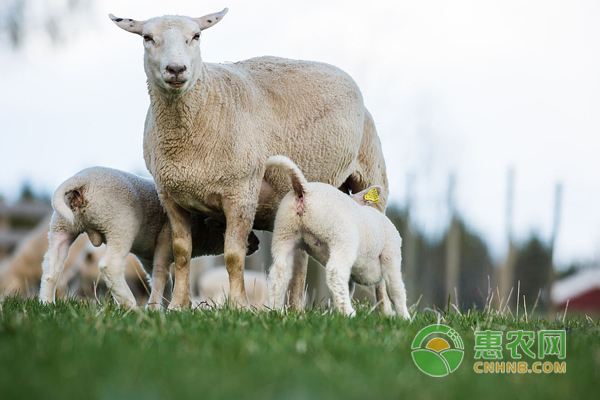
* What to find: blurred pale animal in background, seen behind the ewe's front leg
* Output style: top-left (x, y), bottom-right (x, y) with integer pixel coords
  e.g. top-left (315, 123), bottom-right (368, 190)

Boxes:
top-left (192, 266), bottom-right (269, 308)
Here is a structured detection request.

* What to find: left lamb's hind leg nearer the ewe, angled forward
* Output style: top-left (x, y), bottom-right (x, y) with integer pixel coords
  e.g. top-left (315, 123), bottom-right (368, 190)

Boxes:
top-left (98, 242), bottom-right (137, 309)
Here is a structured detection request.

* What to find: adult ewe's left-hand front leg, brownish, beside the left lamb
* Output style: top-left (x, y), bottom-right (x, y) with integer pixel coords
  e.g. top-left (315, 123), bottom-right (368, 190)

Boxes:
top-left (159, 191), bottom-right (192, 310)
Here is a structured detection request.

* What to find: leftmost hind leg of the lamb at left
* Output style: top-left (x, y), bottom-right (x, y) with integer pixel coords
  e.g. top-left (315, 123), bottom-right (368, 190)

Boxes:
top-left (40, 229), bottom-right (79, 303)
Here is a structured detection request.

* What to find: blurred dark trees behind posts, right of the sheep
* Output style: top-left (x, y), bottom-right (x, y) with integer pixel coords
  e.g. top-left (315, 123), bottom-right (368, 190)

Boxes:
top-left (387, 204), bottom-right (554, 310)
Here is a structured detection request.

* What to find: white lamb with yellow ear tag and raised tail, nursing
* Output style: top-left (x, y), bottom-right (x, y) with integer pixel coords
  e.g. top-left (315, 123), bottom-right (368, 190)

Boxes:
top-left (266, 156), bottom-right (410, 318)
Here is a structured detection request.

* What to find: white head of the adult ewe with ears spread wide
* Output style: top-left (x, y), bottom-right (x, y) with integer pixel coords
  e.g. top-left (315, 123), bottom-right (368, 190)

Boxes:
top-left (109, 8), bottom-right (228, 97)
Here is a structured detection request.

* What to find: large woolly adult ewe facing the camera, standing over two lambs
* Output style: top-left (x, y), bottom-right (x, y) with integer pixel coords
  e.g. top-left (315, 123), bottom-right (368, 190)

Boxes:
top-left (110, 9), bottom-right (387, 308)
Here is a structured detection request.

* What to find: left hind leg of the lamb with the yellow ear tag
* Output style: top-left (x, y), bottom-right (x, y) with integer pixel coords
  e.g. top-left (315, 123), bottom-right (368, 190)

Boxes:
top-left (269, 241), bottom-right (295, 310)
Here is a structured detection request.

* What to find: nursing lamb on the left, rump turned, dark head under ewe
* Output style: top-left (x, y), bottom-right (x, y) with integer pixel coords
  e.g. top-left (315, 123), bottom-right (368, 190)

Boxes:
top-left (40, 167), bottom-right (258, 309)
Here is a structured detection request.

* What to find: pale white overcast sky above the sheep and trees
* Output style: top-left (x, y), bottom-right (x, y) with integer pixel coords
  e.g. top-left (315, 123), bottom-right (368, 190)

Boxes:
top-left (0, 0), bottom-right (600, 266)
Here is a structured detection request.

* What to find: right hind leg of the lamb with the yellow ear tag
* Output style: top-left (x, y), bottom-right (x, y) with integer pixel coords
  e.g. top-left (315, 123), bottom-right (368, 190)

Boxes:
top-left (325, 250), bottom-right (356, 317)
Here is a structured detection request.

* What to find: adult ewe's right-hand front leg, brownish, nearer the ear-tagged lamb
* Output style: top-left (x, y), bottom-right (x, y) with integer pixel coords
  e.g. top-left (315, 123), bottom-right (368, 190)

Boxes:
top-left (223, 195), bottom-right (258, 307)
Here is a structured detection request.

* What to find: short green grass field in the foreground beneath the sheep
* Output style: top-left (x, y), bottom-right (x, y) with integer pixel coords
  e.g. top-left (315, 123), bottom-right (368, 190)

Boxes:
top-left (0, 298), bottom-right (600, 400)
